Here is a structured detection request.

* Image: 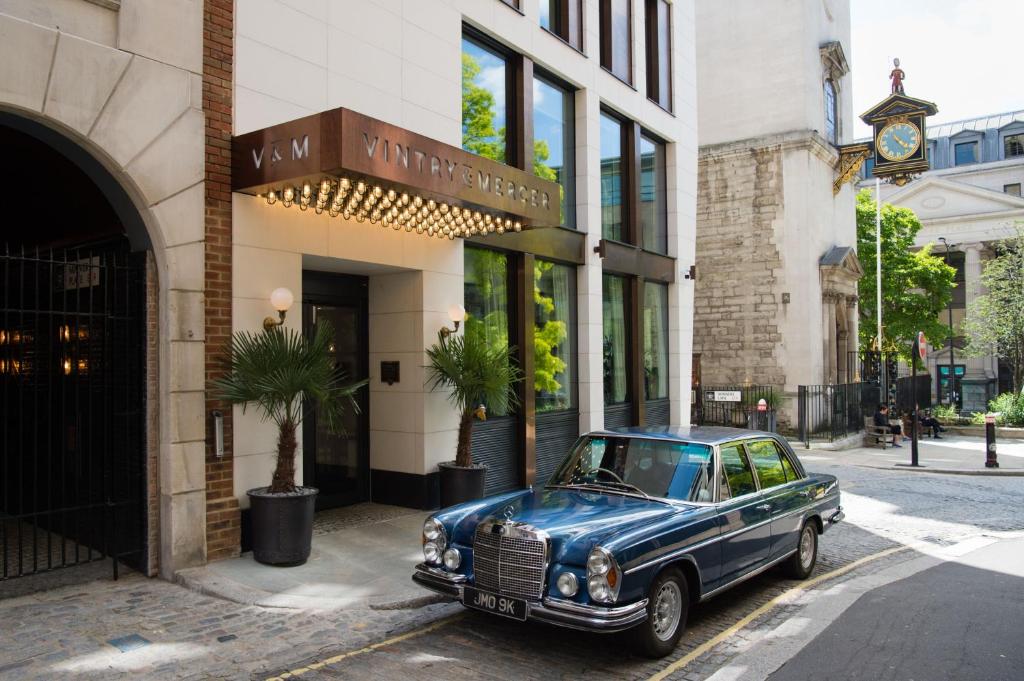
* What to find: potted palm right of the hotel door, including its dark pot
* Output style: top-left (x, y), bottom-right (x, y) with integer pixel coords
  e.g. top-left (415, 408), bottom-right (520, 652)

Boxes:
top-left (427, 330), bottom-right (522, 508)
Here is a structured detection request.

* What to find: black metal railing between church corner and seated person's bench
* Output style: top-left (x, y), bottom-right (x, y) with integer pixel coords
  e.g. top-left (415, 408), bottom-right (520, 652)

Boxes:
top-left (797, 383), bottom-right (878, 446)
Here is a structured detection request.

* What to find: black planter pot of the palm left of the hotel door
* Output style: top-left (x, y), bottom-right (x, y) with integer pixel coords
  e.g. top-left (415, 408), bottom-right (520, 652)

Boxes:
top-left (246, 487), bottom-right (318, 567)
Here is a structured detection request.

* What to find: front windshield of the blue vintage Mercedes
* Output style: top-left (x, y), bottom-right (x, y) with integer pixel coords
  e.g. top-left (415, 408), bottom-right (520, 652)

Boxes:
top-left (548, 435), bottom-right (713, 502)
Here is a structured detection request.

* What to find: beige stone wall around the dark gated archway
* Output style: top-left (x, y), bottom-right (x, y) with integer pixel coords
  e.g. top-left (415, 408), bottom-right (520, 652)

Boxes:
top-left (0, 0), bottom-right (206, 577)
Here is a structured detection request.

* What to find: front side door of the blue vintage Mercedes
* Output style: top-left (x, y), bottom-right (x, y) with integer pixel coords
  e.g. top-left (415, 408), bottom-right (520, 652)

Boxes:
top-left (719, 442), bottom-right (771, 584)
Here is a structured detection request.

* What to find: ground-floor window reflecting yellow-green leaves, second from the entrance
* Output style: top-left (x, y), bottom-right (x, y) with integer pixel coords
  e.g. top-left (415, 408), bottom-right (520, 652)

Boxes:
top-left (534, 260), bottom-right (577, 414)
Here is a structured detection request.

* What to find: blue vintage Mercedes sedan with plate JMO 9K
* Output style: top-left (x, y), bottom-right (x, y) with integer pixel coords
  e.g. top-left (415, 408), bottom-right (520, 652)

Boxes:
top-left (413, 427), bottom-right (843, 656)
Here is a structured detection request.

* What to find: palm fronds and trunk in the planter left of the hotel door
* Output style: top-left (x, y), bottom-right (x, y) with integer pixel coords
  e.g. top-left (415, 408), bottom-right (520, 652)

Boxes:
top-left (213, 321), bottom-right (367, 493)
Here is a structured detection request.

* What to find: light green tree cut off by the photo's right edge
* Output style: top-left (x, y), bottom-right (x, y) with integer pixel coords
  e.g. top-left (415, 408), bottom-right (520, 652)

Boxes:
top-left (964, 225), bottom-right (1024, 391)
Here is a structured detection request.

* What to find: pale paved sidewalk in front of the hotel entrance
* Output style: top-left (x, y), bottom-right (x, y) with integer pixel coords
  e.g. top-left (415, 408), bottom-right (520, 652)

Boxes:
top-left (175, 504), bottom-right (430, 611)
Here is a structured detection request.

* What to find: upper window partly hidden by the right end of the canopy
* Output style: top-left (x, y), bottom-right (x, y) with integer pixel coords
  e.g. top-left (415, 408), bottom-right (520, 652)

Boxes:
top-left (534, 78), bottom-right (575, 226)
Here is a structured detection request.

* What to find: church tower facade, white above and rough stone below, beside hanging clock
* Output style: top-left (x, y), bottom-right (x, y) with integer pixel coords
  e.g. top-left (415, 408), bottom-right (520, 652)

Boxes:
top-left (693, 0), bottom-right (861, 428)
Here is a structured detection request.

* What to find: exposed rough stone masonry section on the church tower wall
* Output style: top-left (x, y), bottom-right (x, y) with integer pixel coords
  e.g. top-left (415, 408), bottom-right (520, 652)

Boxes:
top-left (693, 145), bottom-right (785, 395)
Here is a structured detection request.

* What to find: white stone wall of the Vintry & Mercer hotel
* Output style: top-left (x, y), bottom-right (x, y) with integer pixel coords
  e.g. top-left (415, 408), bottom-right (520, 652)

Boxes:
top-left (234, 0), bottom-right (696, 491)
